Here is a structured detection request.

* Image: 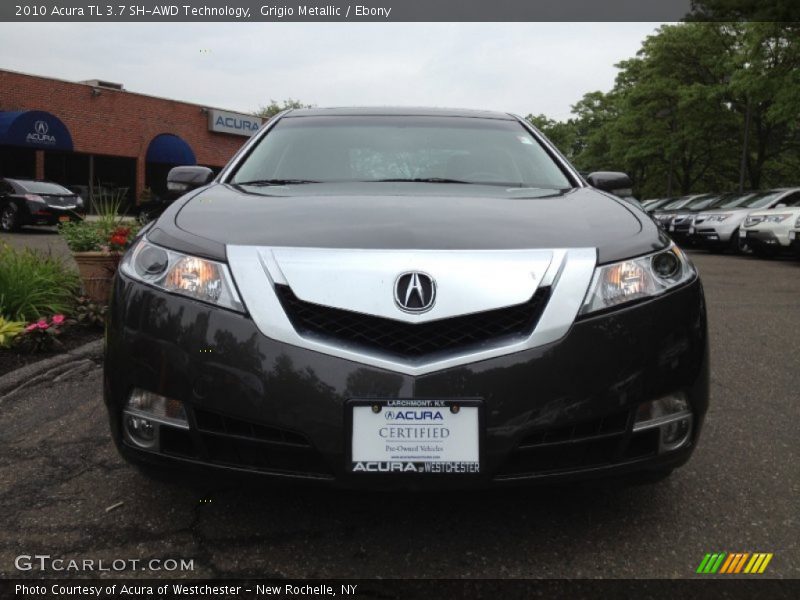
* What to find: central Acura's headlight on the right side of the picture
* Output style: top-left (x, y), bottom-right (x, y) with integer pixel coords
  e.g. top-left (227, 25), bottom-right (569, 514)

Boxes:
top-left (579, 245), bottom-right (696, 315)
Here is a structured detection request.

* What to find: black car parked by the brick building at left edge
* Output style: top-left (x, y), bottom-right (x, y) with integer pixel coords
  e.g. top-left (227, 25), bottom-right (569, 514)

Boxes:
top-left (0, 178), bottom-right (84, 231)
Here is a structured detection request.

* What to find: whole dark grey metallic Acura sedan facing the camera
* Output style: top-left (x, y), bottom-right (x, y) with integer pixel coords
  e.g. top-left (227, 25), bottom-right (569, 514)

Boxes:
top-left (105, 109), bottom-right (708, 489)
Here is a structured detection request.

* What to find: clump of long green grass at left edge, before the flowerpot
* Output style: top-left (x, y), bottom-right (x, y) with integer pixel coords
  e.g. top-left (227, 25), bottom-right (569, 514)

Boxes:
top-left (0, 244), bottom-right (80, 322)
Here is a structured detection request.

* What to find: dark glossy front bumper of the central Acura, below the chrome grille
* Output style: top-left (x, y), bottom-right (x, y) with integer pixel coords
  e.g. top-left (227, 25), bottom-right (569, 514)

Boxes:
top-left (104, 274), bottom-right (708, 488)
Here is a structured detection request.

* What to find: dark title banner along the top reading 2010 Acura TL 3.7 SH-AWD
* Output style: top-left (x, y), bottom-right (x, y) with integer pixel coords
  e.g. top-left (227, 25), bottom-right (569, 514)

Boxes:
top-left (0, 0), bottom-right (800, 22)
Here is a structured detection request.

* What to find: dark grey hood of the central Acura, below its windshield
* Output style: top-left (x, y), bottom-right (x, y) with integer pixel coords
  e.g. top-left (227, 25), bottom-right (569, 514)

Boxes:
top-left (148, 183), bottom-right (669, 262)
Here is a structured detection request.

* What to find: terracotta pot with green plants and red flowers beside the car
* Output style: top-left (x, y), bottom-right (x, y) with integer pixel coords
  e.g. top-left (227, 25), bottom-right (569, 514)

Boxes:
top-left (59, 188), bottom-right (138, 304)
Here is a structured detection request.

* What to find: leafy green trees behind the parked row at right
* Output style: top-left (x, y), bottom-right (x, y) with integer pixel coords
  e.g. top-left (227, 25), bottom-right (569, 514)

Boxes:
top-left (528, 22), bottom-right (800, 197)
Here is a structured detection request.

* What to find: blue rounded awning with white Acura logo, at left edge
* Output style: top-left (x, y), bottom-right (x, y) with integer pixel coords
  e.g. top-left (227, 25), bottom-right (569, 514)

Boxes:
top-left (0, 110), bottom-right (72, 150)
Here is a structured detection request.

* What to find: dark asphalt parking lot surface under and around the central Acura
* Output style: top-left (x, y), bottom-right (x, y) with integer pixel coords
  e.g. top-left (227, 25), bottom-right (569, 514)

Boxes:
top-left (0, 248), bottom-right (800, 578)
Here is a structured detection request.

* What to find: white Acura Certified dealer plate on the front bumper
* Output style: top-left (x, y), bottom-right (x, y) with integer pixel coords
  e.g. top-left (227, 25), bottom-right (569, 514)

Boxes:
top-left (350, 400), bottom-right (480, 474)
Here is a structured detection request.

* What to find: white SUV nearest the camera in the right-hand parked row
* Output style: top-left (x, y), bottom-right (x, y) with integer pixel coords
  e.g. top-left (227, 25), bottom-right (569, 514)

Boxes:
top-left (739, 188), bottom-right (800, 258)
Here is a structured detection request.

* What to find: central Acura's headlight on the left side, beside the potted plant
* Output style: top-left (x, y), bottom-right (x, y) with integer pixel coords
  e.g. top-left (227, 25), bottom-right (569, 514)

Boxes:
top-left (120, 238), bottom-right (244, 312)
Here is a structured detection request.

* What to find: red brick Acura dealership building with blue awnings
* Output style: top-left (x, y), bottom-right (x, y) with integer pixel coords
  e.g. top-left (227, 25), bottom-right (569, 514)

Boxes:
top-left (0, 70), bottom-right (261, 203)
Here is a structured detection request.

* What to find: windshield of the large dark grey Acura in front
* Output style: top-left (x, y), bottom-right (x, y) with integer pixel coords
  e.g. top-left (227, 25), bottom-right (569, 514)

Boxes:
top-left (231, 116), bottom-right (572, 189)
